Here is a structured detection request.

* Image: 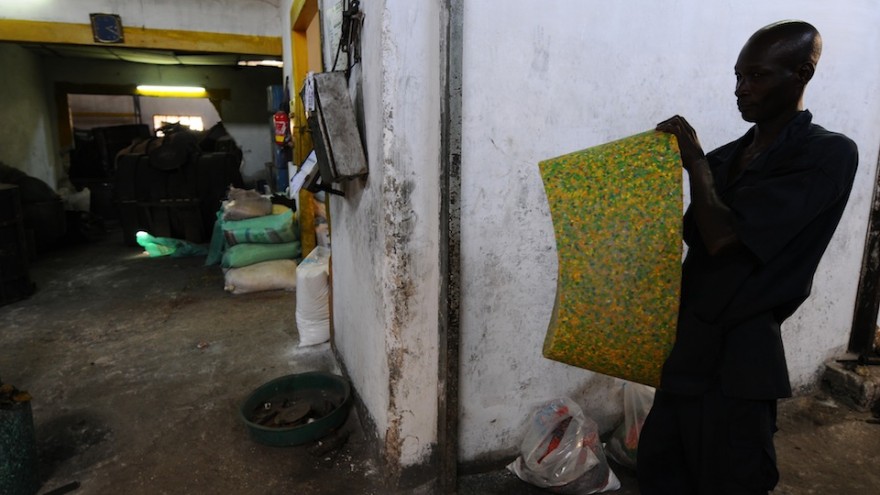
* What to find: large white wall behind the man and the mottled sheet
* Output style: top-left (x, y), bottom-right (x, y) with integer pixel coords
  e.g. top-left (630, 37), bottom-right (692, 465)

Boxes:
top-left (458, 0), bottom-right (880, 461)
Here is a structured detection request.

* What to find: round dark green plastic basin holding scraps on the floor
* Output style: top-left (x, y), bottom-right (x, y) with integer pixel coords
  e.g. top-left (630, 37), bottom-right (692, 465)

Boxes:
top-left (239, 371), bottom-right (351, 447)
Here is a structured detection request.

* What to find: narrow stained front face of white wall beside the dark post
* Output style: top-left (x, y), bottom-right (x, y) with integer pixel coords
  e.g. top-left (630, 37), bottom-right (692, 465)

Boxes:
top-left (374, 0), bottom-right (441, 466)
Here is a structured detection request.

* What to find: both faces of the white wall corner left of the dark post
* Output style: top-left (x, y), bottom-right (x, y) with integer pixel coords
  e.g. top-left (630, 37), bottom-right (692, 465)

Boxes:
top-left (331, 0), bottom-right (440, 467)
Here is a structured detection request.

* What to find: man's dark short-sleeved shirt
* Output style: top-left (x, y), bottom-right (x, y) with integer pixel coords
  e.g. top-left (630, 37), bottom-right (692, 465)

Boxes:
top-left (660, 111), bottom-right (858, 399)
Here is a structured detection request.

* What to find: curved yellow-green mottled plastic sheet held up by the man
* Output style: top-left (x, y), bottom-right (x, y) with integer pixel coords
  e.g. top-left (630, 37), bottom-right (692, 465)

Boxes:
top-left (540, 131), bottom-right (682, 386)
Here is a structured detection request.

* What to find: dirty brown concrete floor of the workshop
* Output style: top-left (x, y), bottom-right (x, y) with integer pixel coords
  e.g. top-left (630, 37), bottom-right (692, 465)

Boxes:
top-left (0, 227), bottom-right (880, 495)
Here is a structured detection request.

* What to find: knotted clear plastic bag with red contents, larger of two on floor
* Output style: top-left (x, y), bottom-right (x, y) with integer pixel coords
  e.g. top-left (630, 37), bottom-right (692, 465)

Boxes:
top-left (507, 398), bottom-right (620, 495)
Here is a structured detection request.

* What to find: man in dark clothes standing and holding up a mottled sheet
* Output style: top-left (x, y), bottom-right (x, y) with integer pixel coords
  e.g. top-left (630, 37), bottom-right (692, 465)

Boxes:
top-left (638, 21), bottom-right (858, 495)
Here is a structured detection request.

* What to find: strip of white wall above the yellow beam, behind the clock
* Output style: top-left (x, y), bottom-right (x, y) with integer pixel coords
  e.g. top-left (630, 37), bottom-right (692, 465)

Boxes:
top-left (0, 0), bottom-right (281, 36)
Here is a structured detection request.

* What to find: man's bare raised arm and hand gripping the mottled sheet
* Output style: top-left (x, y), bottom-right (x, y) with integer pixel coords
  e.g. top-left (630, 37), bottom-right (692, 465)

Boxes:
top-left (657, 115), bottom-right (741, 256)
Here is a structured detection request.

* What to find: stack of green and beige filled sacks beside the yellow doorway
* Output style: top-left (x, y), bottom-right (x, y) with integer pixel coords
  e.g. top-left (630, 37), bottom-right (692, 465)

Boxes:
top-left (205, 188), bottom-right (302, 294)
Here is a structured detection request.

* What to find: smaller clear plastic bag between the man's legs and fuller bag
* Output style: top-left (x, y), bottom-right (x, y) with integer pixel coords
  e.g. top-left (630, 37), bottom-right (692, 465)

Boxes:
top-left (607, 382), bottom-right (654, 469)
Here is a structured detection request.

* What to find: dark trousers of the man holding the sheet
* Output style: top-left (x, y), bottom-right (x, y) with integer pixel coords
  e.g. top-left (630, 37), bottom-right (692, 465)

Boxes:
top-left (638, 387), bottom-right (779, 495)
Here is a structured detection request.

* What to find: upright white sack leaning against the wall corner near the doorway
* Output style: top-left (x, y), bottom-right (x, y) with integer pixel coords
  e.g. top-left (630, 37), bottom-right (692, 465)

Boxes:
top-left (296, 246), bottom-right (330, 347)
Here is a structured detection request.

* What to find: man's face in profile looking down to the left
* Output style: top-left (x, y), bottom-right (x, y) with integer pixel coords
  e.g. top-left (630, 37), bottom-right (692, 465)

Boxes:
top-left (734, 40), bottom-right (804, 123)
